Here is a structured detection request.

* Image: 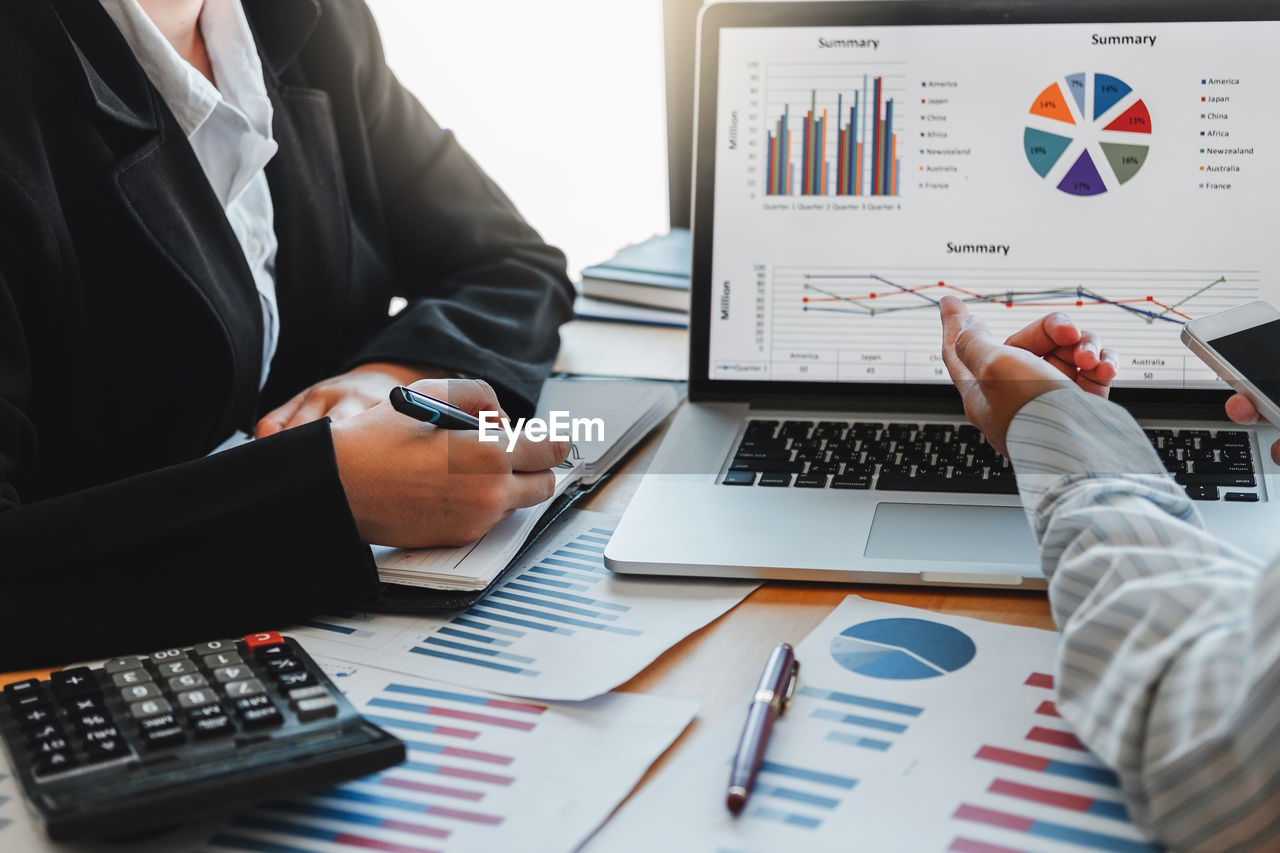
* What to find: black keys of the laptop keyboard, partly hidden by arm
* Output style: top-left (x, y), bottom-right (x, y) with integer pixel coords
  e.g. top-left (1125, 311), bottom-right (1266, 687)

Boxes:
top-left (722, 420), bottom-right (1258, 501)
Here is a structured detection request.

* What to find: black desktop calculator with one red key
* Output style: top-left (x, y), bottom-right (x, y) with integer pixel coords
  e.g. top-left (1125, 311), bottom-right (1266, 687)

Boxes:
top-left (0, 631), bottom-right (404, 840)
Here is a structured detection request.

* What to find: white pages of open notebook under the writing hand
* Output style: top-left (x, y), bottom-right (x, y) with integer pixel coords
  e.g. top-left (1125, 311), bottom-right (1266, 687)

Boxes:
top-left (374, 379), bottom-right (681, 590)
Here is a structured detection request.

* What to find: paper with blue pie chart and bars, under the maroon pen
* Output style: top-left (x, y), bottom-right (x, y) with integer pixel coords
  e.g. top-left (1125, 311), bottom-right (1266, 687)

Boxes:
top-left (588, 597), bottom-right (1155, 853)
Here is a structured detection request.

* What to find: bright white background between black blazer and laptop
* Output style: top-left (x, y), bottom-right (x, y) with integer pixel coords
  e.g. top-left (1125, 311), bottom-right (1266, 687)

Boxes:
top-left (369, 0), bottom-right (668, 278)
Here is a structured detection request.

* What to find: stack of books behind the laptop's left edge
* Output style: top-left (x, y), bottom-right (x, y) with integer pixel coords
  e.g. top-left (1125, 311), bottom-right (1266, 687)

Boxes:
top-left (573, 228), bottom-right (692, 328)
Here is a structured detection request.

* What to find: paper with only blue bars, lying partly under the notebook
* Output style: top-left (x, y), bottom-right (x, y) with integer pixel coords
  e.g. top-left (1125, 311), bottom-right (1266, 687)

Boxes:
top-left (291, 512), bottom-right (756, 701)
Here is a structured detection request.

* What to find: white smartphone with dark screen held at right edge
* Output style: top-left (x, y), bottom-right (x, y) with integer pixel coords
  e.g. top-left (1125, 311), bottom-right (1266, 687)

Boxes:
top-left (1181, 302), bottom-right (1280, 427)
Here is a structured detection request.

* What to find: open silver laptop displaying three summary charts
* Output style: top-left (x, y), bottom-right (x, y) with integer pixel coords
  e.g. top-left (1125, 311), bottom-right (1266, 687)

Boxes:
top-left (605, 0), bottom-right (1280, 589)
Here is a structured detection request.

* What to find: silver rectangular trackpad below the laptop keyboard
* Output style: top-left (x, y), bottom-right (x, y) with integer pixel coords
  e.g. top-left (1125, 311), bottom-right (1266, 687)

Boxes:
top-left (865, 503), bottom-right (1039, 566)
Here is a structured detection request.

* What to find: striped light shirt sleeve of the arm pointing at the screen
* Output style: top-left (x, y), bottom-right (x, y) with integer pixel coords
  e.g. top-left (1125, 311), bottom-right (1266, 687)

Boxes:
top-left (1009, 389), bottom-right (1280, 850)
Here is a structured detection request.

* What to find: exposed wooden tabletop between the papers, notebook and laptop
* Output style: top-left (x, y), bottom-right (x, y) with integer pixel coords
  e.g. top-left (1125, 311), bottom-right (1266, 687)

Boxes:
top-left (584, 422), bottom-right (1053, 785)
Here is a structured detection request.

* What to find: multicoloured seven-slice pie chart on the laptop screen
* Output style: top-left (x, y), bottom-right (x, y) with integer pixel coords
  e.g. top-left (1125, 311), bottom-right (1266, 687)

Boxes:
top-left (1023, 72), bottom-right (1151, 196)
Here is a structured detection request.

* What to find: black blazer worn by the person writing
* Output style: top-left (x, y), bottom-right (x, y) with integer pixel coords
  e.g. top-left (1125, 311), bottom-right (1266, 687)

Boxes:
top-left (0, 0), bottom-right (572, 670)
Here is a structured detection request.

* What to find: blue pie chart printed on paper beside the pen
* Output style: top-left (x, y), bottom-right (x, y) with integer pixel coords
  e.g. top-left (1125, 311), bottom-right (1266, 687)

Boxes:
top-left (831, 619), bottom-right (978, 680)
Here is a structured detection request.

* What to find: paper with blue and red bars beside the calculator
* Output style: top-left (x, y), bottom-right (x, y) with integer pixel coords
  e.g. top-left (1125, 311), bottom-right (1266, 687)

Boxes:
top-left (207, 662), bottom-right (694, 853)
